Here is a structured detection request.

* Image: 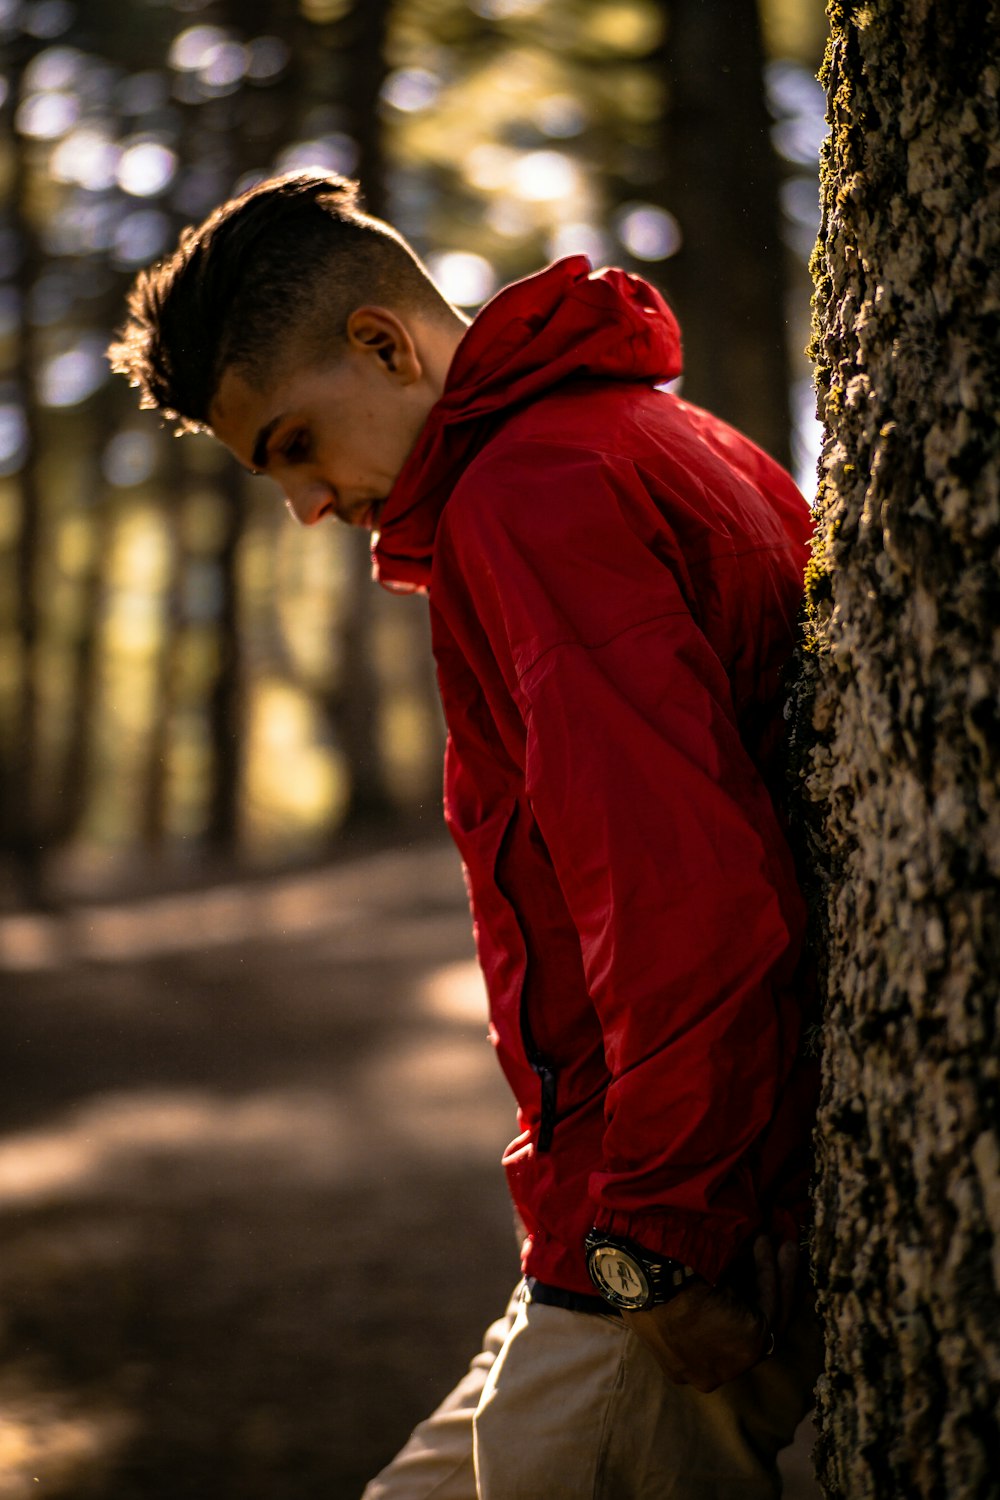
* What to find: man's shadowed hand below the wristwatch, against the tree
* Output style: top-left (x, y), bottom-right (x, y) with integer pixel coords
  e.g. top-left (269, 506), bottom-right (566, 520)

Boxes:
top-left (622, 1235), bottom-right (799, 1392)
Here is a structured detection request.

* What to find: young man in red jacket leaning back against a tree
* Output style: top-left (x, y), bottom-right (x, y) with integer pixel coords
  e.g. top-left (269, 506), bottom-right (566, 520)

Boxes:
top-left (112, 177), bottom-right (816, 1500)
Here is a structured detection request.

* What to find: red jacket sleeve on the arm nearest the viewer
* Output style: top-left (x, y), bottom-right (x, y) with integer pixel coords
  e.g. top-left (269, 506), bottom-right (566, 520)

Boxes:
top-left (437, 441), bottom-right (801, 1281)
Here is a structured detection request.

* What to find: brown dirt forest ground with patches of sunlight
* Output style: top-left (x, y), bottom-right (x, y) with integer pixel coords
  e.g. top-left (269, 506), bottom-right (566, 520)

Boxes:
top-left (0, 845), bottom-right (817, 1500)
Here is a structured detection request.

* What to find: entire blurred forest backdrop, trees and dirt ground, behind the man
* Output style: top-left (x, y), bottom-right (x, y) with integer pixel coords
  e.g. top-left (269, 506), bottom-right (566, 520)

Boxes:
top-left (0, 0), bottom-right (826, 1500)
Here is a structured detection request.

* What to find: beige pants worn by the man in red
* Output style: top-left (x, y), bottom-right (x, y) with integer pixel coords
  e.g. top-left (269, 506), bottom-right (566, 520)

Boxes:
top-left (363, 1287), bottom-right (820, 1500)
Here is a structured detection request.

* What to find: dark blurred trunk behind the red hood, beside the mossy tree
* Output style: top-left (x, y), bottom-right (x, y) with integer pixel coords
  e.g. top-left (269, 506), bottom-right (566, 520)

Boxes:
top-left (661, 0), bottom-right (790, 464)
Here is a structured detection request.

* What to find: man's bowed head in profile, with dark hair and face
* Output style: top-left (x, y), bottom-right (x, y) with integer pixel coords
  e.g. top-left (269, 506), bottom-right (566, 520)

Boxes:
top-left (109, 176), bottom-right (463, 525)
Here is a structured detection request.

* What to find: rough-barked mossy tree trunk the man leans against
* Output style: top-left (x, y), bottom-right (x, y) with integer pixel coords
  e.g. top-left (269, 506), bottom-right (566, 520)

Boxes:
top-left (798, 0), bottom-right (1000, 1500)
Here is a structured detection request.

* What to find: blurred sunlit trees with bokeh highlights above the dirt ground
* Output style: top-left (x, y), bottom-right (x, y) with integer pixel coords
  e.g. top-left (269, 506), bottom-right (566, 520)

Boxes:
top-left (0, 0), bottom-right (825, 903)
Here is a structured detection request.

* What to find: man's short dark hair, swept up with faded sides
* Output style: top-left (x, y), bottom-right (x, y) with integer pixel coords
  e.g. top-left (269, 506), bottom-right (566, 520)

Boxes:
top-left (108, 174), bottom-right (451, 432)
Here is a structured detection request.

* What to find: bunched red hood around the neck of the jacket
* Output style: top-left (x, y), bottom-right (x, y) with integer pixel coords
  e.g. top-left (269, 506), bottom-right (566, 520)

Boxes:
top-left (372, 255), bottom-right (681, 591)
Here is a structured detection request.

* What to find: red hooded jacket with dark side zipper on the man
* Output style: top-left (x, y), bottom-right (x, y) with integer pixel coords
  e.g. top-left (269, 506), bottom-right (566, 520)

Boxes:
top-left (375, 257), bottom-right (814, 1292)
